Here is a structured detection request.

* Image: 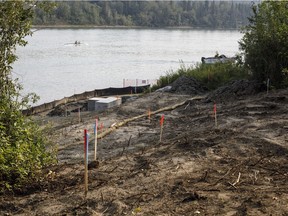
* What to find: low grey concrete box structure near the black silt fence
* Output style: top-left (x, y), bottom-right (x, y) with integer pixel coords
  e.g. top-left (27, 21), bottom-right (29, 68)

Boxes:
top-left (88, 97), bottom-right (122, 111)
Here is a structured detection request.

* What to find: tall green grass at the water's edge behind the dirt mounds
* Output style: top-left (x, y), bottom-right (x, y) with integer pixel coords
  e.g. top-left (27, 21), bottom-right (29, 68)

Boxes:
top-left (152, 63), bottom-right (249, 91)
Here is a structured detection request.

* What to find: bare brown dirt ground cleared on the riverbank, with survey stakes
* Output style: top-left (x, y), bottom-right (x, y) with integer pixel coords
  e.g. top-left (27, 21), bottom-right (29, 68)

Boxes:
top-left (0, 80), bottom-right (288, 216)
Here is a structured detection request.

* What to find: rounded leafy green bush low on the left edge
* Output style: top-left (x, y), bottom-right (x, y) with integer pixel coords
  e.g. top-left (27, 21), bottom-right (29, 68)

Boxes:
top-left (0, 98), bottom-right (56, 192)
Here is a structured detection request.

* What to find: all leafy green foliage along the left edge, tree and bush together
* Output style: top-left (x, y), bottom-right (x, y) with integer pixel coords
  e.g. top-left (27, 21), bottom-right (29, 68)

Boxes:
top-left (0, 1), bottom-right (53, 192)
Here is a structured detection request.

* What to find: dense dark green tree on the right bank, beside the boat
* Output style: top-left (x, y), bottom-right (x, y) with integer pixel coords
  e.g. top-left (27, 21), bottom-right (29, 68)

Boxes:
top-left (240, 1), bottom-right (288, 87)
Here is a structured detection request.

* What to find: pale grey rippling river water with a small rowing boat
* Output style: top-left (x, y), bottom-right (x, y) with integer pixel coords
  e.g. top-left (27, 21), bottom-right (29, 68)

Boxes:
top-left (13, 29), bottom-right (242, 104)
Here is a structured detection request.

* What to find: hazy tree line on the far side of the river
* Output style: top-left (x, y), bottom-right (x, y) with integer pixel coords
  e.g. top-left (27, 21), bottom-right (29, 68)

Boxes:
top-left (33, 1), bottom-right (252, 29)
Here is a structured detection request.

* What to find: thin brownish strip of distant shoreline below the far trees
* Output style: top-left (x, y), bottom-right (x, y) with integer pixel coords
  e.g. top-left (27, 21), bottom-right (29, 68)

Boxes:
top-left (32, 25), bottom-right (240, 31)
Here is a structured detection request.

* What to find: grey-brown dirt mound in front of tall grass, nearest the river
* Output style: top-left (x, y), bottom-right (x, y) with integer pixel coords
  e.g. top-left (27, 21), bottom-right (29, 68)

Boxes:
top-left (170, 76), bottom-right (207, 95)
